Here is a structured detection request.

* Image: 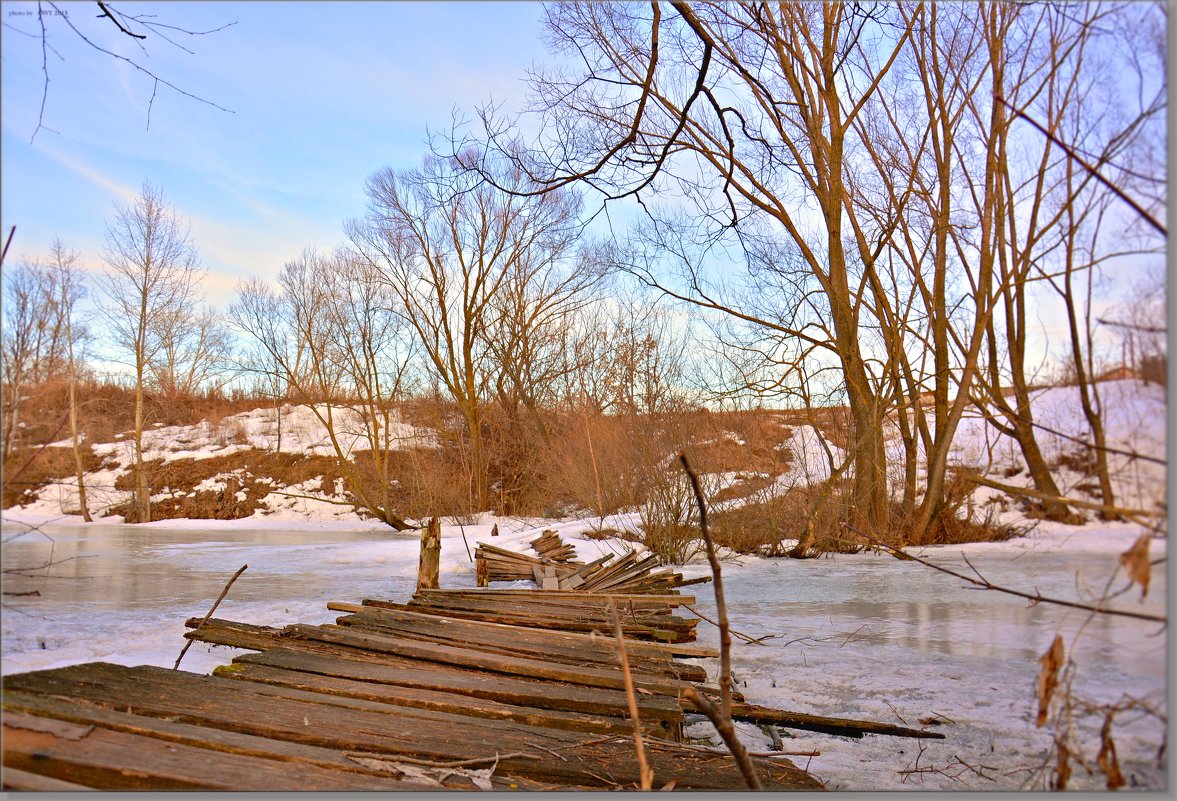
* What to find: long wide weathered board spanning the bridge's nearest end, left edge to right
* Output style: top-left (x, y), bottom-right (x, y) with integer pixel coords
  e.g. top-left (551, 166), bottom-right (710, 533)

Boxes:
top-left (6, 663), bottom-right (819, 789)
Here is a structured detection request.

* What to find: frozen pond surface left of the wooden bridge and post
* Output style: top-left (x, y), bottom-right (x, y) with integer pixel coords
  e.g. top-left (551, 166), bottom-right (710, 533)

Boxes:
top-left (2, 517), bottom-right (417, 673)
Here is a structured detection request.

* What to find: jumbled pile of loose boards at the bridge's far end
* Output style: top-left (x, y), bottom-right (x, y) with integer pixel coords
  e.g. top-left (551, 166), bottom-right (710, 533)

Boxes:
top-left (474, 530), bottom-right (711, 595)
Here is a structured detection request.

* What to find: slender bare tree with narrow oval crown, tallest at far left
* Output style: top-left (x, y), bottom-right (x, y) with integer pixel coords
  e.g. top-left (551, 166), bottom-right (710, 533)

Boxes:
top-left (102, 183), bottom-right (202, 522)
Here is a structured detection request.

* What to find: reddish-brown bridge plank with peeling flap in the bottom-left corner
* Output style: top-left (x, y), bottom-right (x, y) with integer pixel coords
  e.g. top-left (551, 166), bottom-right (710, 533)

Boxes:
top-left (4, 713), bottom-right (441, 792)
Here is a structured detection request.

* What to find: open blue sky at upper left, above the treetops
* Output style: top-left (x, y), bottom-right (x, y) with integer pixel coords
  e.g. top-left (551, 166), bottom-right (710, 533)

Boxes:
top-left (0, 2), bottom-right (545, 307)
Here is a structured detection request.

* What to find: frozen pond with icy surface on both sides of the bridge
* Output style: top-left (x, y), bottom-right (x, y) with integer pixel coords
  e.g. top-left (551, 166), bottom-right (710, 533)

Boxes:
top-left (2, 515), bottom-right (1166, 790)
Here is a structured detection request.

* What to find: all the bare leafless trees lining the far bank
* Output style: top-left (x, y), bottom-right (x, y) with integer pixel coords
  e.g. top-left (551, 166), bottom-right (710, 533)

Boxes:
top-left (4, 2), bottom-right (1166, 542)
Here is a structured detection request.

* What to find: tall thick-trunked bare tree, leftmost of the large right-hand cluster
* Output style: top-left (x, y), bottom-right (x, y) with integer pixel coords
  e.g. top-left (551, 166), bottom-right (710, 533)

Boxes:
top-left (463, 4), bottom-right (910, 529)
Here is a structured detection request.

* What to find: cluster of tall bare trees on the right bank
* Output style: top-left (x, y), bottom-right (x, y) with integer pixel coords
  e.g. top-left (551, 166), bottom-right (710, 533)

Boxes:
top-left (455, 2), bottom-right (1165, 542)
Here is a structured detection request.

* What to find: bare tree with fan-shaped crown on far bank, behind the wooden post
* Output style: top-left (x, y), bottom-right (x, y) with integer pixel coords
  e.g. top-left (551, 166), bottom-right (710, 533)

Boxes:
top-left (350, 150), bottom-right (579, 509)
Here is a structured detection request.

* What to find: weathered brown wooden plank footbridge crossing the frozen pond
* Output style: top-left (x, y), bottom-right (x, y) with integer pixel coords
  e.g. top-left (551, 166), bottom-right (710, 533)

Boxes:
top-left (2, 536), bottom-right (939, 790)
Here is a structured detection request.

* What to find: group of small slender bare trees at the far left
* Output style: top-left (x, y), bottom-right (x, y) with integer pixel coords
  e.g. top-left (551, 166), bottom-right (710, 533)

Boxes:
top-left (4, 183), bottom-right (231, 522)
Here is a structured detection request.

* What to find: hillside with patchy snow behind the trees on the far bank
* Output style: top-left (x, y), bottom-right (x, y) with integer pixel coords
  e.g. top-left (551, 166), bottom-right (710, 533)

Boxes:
top-left (5, 380), bottom-right (1166, 536)
